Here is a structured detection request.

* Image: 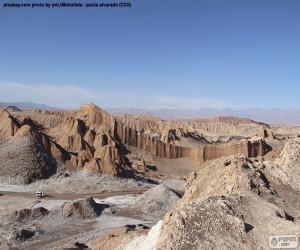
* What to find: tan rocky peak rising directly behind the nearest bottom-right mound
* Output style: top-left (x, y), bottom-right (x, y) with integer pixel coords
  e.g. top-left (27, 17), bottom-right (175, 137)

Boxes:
top-left (182, 155), bottom-right (274, 206)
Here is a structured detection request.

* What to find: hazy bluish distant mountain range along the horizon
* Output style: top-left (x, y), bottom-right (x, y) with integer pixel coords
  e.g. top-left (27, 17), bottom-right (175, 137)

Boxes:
top-left (0, 102), bottom-right (300, 125)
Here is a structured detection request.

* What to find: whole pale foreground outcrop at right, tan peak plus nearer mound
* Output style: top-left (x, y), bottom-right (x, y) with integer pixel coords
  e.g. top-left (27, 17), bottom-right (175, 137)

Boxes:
top-left (156, 156), bottom-right (300, 250)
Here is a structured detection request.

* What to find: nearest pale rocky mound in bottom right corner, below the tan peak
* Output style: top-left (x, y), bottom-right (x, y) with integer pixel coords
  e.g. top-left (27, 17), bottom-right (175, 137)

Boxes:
top-left (157, 193), bottom-right (300, 250)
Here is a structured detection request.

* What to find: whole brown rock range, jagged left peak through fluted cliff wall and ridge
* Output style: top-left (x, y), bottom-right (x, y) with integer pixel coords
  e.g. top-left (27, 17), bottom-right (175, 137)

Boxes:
top-left (0, 104), bottom-right (271, 181)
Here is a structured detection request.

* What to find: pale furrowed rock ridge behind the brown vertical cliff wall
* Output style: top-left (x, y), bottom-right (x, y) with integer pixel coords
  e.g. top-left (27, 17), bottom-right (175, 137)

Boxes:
top-left (120, 115), bottom-right (272, 138)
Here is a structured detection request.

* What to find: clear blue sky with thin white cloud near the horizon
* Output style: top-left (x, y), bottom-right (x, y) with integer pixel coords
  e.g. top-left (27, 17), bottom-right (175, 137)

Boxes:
top-left (0, 0), bottom-right (300, 109)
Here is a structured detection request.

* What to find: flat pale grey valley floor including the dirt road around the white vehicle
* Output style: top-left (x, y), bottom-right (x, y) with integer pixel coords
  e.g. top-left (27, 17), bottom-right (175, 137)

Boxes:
top-left (0, 172), bottom-right (164, 250)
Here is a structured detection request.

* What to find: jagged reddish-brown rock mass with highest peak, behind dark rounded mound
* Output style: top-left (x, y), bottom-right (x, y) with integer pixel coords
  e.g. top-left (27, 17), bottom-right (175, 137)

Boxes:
top-left (0, 105), bottom-right (134, 179)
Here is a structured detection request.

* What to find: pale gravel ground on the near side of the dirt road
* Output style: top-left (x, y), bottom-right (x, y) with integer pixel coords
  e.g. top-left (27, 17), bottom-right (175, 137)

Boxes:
top-left (0, 192), bottom-right (154, 249)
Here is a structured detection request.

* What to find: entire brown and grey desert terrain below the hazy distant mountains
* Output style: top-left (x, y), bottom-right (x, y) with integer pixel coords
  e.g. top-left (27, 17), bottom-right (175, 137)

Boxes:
top-left (0, 103), bottom-right (300, 250)
